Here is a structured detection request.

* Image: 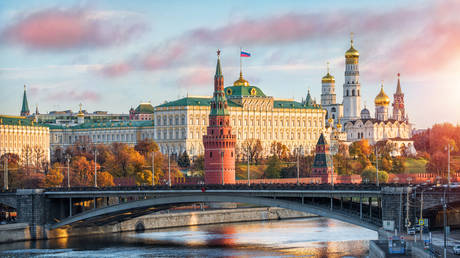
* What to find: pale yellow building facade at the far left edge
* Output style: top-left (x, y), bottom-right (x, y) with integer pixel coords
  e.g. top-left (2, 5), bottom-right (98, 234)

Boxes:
top-left (0, 124), bottom-right (50, 161)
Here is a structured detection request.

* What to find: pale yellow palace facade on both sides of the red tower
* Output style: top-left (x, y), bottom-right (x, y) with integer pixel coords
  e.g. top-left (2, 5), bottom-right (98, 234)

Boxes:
top-left (154, 98), bottom-right (326, 156)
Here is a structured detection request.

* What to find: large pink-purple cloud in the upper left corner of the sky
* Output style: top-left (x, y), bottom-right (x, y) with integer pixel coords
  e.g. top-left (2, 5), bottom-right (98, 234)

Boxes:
top-left (0, 8), bottom-right (147, 51)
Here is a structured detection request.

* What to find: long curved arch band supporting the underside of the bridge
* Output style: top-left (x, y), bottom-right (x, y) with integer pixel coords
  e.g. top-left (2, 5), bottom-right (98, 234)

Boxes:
top-left (50, 193), bottom-right (378, 231)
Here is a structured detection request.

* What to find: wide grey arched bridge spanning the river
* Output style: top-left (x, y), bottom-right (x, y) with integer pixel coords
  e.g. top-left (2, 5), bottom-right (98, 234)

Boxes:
top-left (0, 184), bottom-right (460, 234)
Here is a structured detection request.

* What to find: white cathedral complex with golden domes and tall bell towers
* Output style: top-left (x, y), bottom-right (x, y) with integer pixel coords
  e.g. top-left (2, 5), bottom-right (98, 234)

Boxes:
top-left (321, 35), bottom-right (415, 155)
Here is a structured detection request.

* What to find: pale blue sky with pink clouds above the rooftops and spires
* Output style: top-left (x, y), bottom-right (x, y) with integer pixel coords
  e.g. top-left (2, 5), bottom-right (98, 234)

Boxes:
top-left (0, 0), bottom-right (460, 128)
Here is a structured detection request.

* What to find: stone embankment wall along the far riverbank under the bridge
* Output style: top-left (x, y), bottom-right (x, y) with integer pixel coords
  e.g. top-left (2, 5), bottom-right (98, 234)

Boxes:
top-left (0, 207), bottom-right (316, 243)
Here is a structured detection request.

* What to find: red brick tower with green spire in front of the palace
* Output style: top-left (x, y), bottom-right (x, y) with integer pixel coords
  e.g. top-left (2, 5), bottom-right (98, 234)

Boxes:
top-left (203, 50), bottom-right (236, 184)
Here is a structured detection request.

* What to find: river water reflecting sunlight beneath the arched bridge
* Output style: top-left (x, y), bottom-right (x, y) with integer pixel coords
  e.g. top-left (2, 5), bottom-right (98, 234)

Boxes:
top-left (0, 217), bottom-right (377, 258)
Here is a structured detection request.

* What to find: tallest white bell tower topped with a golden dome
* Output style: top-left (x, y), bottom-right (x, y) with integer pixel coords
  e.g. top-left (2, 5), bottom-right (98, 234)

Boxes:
top-left (343, 34), bottom-right (361, 123)
